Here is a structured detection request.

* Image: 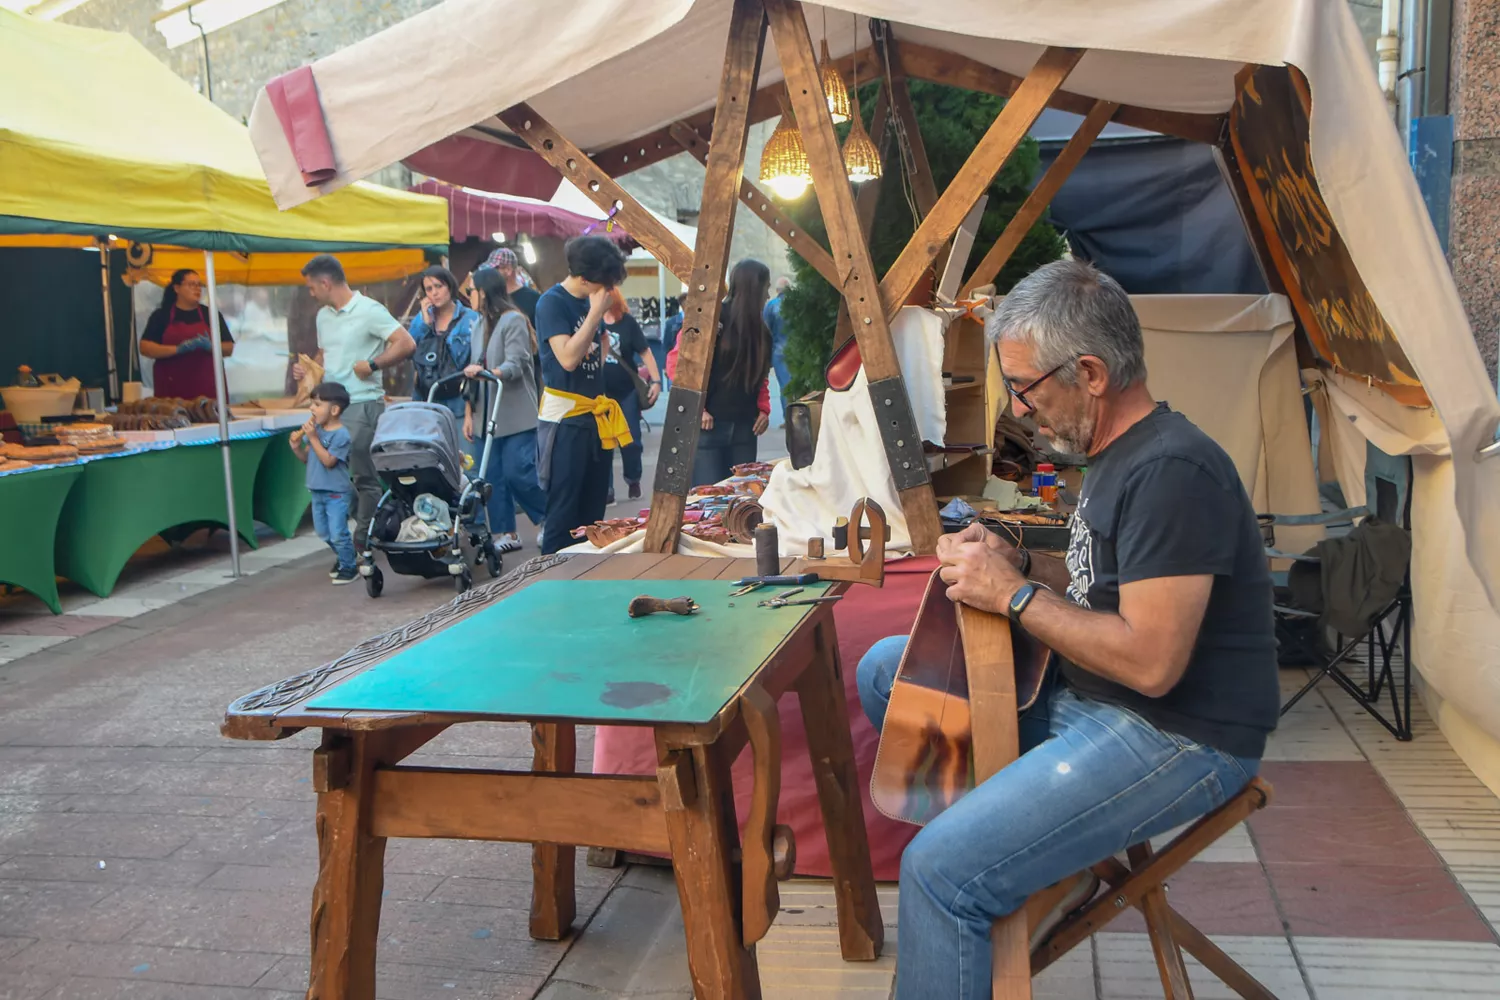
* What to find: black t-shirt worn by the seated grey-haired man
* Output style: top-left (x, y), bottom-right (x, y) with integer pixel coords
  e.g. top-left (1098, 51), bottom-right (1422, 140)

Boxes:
top-left (1062, 403), bottom-right (1280, 757)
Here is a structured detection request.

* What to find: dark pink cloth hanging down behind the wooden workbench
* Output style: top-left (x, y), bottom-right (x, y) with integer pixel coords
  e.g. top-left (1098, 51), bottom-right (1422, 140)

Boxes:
top-left (594, 558), bottom-right (938, 882)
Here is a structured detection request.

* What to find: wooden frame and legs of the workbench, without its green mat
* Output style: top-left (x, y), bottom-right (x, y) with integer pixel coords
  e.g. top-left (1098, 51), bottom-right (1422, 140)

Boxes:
top-left (222, 553), bottom-right (884, 1000)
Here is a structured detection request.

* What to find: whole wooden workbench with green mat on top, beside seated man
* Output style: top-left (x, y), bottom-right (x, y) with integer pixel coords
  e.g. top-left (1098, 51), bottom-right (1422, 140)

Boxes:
top-left (222, 553), bottom-right (884, 1000)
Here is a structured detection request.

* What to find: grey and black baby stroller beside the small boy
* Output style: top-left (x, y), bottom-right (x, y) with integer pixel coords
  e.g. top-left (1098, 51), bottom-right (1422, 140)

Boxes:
top-left (359, 372), bottom-right (500, 597)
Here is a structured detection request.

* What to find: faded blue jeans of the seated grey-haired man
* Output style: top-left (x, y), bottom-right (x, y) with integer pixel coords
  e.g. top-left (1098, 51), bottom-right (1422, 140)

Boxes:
top-left (857, 636), bottom-right (1260, 1000)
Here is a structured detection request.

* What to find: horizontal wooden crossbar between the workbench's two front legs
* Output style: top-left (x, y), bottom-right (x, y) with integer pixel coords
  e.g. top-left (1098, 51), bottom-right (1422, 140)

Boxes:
top-left (369, 766), bottom-right (669, 853)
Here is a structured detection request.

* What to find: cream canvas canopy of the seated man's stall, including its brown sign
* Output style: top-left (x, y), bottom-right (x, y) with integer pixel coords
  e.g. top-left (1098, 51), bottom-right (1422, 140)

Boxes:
top-left (251, 0), bottom-right (1500, 787)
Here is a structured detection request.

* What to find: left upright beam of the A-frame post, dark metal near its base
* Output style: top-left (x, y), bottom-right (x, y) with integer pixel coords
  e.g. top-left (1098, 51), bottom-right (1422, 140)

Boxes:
top-left (645, 0), bottom-right (768, 552)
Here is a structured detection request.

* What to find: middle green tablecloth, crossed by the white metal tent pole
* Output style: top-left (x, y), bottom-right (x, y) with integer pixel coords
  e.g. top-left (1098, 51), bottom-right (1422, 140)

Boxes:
top-left (56, 435), bottom-right (272, 597)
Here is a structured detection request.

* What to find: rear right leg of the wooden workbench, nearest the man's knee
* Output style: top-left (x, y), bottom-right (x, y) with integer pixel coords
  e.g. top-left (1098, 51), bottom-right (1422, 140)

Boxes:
top-left (797, 615), bottom-right (885, 961)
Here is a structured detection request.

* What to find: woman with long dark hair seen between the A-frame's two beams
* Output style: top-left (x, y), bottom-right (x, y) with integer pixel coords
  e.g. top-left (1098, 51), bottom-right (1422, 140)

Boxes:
top-left (666, 258), bottom-right (771, 486)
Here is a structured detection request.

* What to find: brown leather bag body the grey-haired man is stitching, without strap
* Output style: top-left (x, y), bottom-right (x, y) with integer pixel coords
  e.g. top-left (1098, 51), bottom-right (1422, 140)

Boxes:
top-left (870, 573), bottom-right (1052, 825)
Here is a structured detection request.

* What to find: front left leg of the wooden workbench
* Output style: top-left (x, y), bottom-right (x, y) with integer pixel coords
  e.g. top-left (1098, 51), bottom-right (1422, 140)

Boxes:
top-left (308, 730), bottom-right (387, 1000)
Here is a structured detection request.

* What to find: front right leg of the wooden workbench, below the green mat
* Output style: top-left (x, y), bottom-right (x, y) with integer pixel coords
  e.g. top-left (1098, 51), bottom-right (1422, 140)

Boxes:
top-left (657, 735), bottom-right (761, 1000)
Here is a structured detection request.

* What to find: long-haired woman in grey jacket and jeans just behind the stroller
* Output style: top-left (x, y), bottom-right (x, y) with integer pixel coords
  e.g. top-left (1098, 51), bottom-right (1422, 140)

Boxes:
top-left (464, 268), bottom-right (548, 553)
